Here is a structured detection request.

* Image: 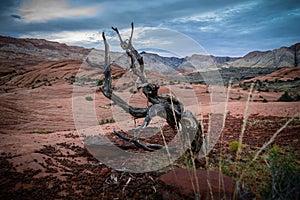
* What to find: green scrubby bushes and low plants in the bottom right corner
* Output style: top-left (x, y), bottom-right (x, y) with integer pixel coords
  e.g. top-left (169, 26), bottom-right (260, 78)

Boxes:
top-left (219, 142), bottom-right (300, 199)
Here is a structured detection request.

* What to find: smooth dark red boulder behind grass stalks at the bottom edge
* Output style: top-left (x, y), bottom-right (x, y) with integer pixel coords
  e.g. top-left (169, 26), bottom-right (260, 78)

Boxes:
top-left (160, 168), bottom-right (236, 199)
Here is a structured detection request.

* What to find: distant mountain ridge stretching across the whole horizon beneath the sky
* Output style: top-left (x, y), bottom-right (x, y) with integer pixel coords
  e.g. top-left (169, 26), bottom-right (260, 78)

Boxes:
top-left (0, 36), bottom-right (300, 73)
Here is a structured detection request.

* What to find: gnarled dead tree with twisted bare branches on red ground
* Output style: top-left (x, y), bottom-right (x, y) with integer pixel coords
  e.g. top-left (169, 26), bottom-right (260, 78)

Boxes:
top-left (100, 23), bottom-right (204, 158)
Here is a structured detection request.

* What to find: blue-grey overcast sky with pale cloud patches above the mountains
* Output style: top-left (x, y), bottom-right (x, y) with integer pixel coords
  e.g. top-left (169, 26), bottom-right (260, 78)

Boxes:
top-left (0, 0), bottom-right (300, 56)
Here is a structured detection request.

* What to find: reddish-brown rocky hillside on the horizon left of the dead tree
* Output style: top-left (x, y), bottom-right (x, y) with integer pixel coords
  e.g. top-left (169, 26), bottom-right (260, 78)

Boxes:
top-left (0, 36), bottom-right (90, 70)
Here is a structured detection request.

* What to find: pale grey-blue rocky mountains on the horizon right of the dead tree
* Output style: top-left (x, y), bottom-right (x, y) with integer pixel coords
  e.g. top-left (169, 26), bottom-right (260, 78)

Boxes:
top-left (118, 43), bottom-right (300, 73)
